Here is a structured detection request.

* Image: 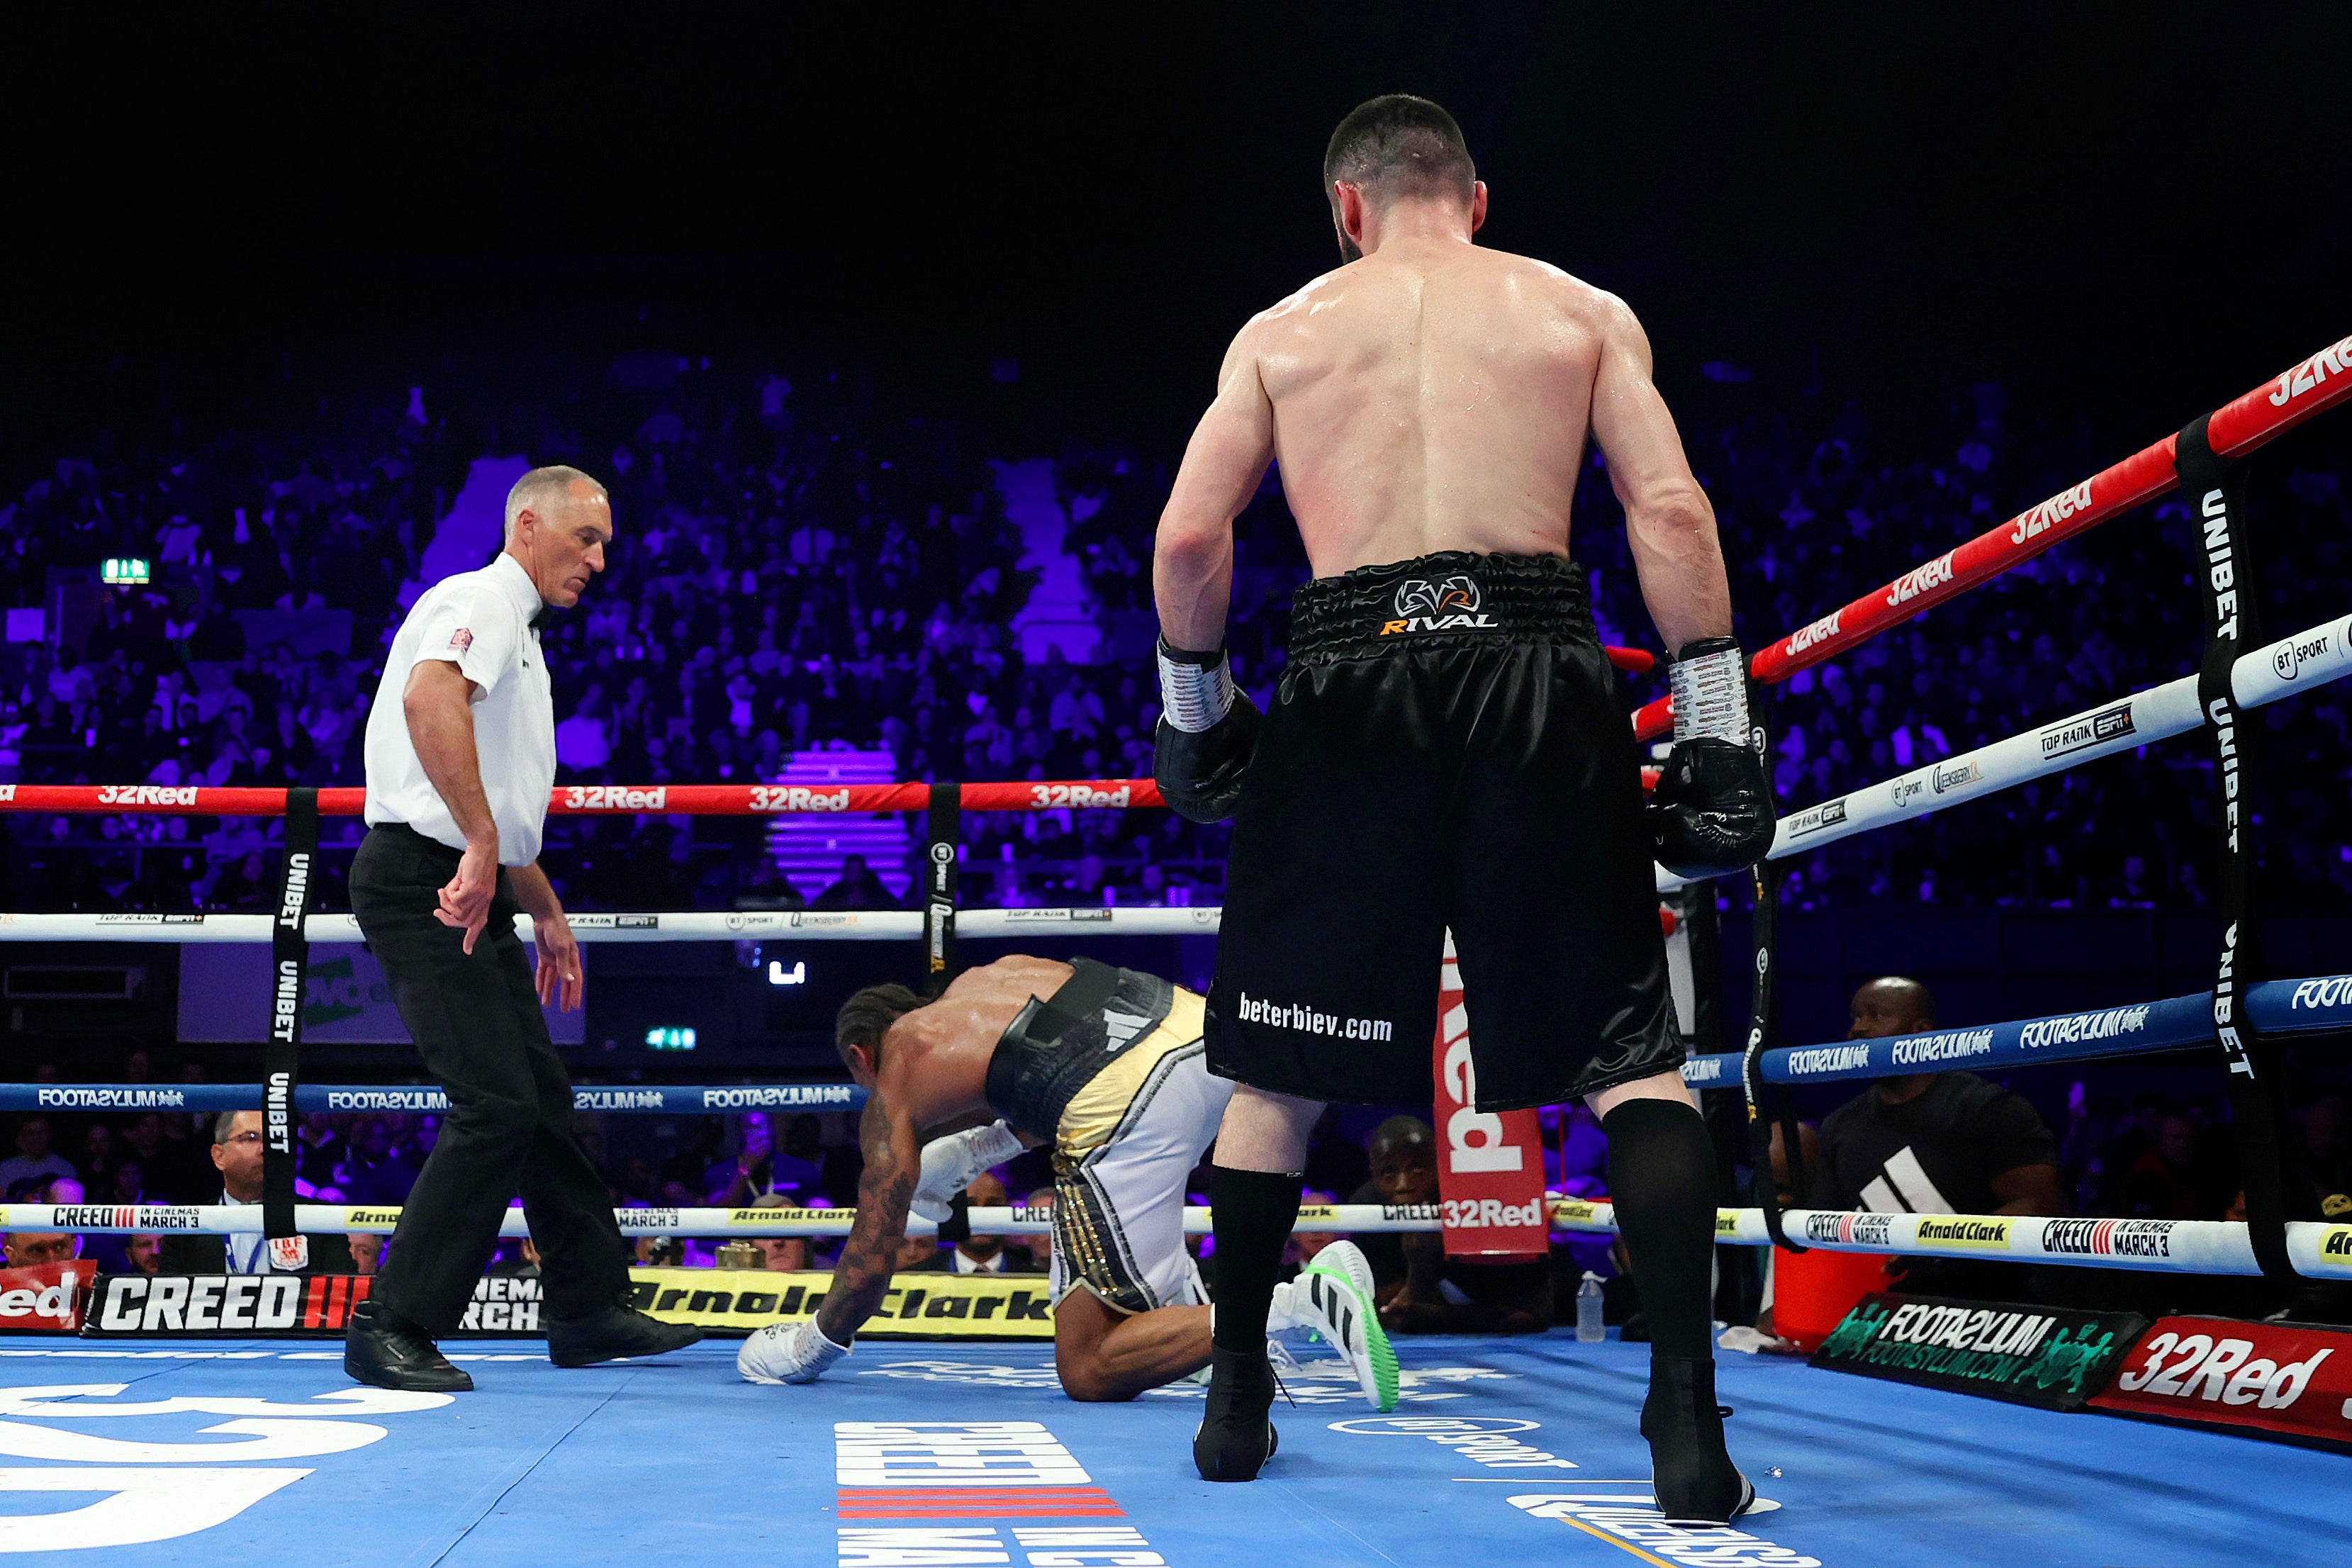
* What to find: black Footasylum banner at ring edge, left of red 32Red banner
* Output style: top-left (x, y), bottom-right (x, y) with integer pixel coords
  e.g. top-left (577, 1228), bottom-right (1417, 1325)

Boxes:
top-left (1811, 1293), bottom-right (2147, 1411)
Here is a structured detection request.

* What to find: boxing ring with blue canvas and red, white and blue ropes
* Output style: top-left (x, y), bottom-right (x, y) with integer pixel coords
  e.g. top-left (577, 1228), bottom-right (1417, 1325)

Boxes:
top-left (0, 339), bottom-right (2352, 1568)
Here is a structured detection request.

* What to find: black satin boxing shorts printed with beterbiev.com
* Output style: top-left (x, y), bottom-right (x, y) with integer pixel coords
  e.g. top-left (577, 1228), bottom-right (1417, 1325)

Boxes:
top-left (1206, 552), bottom-right (1684, 1109)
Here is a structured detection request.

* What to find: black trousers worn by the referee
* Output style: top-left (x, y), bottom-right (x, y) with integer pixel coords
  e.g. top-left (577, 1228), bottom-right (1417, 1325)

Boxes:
top-left (350, 825), bottom-right (628, 1338)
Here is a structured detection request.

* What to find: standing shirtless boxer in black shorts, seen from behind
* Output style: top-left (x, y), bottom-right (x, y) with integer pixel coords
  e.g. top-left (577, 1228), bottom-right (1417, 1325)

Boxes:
top-left (1153, 94), bottom-right (1774, 1523)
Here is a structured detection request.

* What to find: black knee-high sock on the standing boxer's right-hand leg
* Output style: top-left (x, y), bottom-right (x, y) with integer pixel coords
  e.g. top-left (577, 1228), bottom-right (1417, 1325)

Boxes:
top-left (1608, 1100), bottom-right (1715, 1357)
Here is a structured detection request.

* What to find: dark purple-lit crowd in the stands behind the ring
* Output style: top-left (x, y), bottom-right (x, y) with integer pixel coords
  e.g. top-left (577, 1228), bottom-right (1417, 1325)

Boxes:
top-left (0, 355), bottom-right (2352, 909)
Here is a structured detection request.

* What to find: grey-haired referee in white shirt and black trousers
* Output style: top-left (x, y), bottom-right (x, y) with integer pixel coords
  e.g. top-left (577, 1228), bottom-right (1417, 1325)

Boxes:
top-left (343, 468), bottom-right (701, 1391)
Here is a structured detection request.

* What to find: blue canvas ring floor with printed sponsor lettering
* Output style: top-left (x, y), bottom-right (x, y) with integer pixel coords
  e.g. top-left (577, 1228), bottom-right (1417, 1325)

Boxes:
top-left (0, 1333), bottom-right (2345, 1568)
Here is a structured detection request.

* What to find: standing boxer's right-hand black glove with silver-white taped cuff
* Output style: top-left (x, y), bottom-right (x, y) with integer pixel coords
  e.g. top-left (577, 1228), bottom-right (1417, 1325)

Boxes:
top-left (1644, 637), bottom-right (1778, 882)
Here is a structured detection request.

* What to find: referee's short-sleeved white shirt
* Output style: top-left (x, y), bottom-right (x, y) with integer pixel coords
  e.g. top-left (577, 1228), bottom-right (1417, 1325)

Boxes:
top-left (367, 555), bottom-right (555, 865)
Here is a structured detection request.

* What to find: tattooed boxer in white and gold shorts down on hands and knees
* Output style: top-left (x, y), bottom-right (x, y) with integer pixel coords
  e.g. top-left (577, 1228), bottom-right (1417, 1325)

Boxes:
top-left (737, 957), bottom-right (1397, 1411)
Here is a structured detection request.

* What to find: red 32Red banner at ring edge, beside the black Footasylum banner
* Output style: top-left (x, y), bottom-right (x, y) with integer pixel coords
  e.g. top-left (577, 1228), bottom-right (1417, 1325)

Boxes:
top-left (2091, 1316), bottom-right (2352, 1450)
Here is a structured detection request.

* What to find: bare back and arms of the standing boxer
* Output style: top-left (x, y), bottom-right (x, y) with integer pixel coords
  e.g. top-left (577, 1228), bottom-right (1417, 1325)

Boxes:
top-left (1157, 202), bottom-right (1731, 649)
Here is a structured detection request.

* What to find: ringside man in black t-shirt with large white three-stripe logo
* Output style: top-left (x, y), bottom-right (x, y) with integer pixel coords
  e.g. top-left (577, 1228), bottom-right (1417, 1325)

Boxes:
top-left (1813, 975), bottom-right (2063, 1298)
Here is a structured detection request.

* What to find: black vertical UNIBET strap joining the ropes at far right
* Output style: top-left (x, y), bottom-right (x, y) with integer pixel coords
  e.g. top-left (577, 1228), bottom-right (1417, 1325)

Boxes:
top-left (2173, 416), bottom-right (2319, 1281)
